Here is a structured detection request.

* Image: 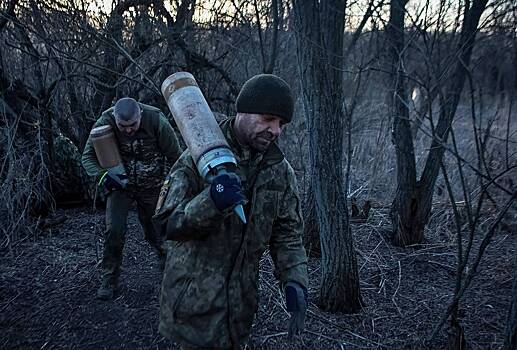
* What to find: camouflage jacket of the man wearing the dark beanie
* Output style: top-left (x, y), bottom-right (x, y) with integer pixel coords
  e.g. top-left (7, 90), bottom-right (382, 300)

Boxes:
top-left (153, 119), bottom-right (308, 349)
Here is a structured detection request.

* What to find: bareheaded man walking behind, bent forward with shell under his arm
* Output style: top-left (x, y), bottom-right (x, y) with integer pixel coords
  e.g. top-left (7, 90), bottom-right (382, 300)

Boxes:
top-left (82, 98), bottom-right (181, 300)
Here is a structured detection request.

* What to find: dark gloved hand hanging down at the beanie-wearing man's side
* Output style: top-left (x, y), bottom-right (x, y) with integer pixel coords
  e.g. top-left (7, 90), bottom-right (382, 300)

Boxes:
top-left (285, 282), bottom-right (307, 339)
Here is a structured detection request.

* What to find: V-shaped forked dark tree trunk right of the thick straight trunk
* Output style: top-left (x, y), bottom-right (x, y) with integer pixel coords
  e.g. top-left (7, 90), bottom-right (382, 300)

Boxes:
top-left (387, 0), bottom-right (488, 246)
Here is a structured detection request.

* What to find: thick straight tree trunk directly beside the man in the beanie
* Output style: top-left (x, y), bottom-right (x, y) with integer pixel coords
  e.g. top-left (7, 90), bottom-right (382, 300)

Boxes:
top-left (294, 0), bottom-right (361, 313)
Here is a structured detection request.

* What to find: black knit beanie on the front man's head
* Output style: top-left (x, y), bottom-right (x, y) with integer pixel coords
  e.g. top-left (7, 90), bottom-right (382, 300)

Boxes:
top-left (236, 74), bottom-right (294, 123)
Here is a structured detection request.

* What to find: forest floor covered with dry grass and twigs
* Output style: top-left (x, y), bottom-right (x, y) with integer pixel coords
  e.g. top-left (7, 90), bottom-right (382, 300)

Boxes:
top-left (0, 204), bottom-right (517, 350)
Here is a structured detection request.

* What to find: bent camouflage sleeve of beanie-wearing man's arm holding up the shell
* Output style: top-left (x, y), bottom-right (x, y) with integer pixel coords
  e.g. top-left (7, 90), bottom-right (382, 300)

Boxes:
top-left (153, 151), bottom-right (224, 241)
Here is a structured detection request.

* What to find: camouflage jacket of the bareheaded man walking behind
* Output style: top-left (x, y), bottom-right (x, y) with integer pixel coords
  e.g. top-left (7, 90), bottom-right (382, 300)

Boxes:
top-left (82, 103), bottom-right (181, 190)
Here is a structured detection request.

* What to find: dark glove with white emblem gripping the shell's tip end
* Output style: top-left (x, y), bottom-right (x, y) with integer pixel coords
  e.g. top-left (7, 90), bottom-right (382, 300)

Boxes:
top-left (210, 173), bottom-right (246, 211)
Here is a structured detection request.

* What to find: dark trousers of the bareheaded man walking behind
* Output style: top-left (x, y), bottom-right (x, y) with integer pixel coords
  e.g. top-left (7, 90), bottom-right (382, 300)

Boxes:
top-left (101, 189), bottom-right (164, 285)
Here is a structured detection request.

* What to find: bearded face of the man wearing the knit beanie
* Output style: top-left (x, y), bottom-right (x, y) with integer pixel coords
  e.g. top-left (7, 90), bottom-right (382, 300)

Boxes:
top-left (235, 113), bottom-right (285, 152)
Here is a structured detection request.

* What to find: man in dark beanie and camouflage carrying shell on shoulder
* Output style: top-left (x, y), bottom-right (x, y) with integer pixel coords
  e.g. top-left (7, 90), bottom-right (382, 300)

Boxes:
top-left (153, 74), bottom-right (308, 349)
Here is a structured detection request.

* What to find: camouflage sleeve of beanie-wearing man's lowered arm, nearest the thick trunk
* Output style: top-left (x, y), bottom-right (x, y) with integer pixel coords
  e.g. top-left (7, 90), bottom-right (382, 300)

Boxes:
top-left (269, 166), bottom-right (308, 288)
